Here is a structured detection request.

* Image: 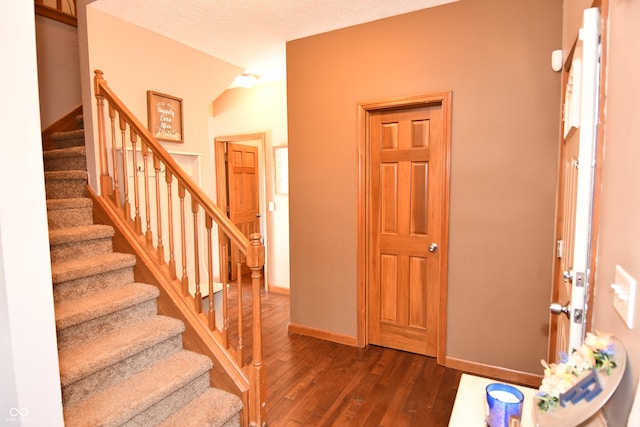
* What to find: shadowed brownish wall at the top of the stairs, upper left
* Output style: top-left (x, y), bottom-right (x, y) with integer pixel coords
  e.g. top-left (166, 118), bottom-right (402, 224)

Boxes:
top-left (36, 15), bottom-right (82, 129)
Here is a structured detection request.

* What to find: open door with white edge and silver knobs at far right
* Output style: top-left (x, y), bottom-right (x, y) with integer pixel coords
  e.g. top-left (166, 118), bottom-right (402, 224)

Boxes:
top-left (549, 8), bottom-right (600, 361)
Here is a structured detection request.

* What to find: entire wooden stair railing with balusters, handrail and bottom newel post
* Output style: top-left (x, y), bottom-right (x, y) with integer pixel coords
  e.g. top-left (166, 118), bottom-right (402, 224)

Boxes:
top-left (94, 70), bottom-right (266, 426)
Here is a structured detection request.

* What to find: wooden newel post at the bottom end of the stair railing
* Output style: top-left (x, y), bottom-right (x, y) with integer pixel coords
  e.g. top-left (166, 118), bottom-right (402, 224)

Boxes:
top-left (247, 233), bottom-right (267, 426)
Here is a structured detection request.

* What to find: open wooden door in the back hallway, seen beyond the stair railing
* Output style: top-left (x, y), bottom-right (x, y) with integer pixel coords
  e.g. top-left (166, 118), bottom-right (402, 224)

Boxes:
top-left (227, 143), bottom-right (260, 280)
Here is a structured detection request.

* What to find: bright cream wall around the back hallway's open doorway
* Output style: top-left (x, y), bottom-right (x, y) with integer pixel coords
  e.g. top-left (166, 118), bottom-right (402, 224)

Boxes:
top-left (210, 81), bottom-right (289, 289)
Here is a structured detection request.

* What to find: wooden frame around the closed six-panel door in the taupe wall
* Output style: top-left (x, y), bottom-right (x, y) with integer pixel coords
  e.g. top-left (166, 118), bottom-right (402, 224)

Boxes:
top-left (356, 92), bottom-right (451, 365)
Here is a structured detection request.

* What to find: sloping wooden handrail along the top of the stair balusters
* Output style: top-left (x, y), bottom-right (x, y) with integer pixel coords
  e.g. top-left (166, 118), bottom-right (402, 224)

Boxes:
top-left (94, 70), bottom-right (250, 255)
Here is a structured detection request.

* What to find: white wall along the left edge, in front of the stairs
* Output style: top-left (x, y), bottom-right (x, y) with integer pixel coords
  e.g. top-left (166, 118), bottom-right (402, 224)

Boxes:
top-left (0, 2), bottom-right (64, 427)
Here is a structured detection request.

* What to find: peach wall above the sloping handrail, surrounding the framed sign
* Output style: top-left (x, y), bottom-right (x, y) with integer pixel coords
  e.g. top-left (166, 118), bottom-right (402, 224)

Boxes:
top-left (82, 5), bottom-right (242, 196)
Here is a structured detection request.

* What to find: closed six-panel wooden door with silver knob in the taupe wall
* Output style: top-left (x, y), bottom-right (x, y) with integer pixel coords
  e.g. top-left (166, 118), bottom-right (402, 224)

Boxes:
top-left (368, 104), bottom-right (444, 356)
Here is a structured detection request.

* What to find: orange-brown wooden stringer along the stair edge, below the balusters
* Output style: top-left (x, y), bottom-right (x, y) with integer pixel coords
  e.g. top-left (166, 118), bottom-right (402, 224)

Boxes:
top-left (87, 185), bottom-right (250, 426)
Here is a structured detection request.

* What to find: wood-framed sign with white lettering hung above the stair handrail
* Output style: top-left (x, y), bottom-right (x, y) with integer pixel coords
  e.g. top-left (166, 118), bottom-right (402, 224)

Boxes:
top-left (147, 90), bottom-right (184, 142)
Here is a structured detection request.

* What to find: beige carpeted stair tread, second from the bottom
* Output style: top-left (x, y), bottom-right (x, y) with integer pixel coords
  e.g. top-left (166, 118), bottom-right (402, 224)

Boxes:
top-left (65, 351), bottom-right (212, 427)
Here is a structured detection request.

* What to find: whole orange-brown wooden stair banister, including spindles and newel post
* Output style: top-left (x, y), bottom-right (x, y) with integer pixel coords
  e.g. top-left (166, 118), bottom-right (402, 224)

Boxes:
top-left (94, 70), bottom-right (267, 426)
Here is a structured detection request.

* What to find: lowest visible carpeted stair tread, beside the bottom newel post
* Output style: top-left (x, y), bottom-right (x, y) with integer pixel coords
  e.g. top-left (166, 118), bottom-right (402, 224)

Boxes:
top-left (158, 388), bottom-right (242, 427)
